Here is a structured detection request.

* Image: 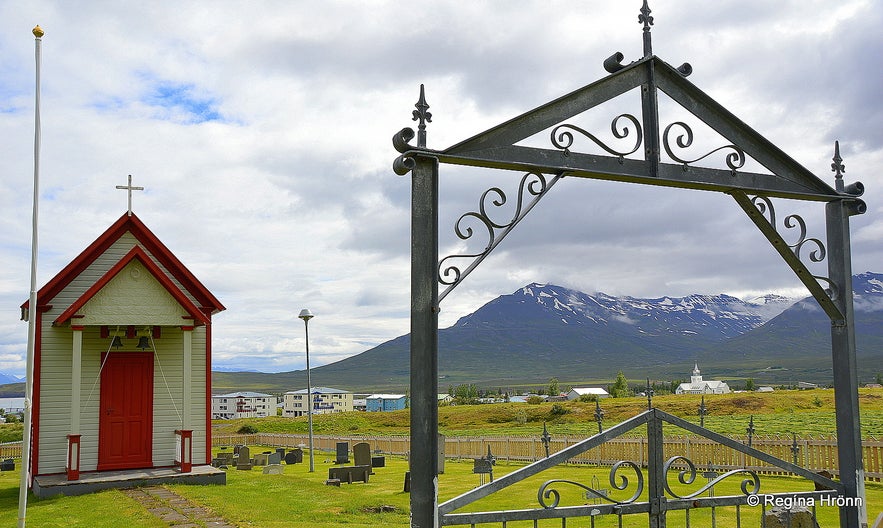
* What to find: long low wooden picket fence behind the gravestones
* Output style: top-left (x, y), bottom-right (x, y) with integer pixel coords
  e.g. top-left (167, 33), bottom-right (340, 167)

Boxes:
top-left (213, 433), bottom-right (883, 481)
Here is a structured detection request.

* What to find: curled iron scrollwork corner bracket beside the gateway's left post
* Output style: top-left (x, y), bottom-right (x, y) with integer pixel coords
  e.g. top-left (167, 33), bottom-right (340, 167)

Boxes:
top-left (438, 172), bottom-right (561, 302)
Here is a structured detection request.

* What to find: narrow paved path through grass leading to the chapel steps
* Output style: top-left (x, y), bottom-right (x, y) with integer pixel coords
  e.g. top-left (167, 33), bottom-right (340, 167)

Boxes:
top-left (122, 486), bottom-right (236, 528)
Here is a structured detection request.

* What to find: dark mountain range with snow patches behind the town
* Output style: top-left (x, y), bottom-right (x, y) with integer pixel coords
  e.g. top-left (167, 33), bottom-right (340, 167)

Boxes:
top-left (213, 272), bottom-right (883, 393)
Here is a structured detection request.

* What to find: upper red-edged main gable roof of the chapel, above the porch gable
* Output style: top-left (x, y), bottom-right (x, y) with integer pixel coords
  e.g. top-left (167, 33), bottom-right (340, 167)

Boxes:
top-left (22, 213), bottom-right (224, 320)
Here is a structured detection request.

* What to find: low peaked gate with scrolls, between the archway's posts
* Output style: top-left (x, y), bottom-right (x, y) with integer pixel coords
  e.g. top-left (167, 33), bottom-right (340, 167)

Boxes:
top-left (438, 409), bottom-right (844, 527)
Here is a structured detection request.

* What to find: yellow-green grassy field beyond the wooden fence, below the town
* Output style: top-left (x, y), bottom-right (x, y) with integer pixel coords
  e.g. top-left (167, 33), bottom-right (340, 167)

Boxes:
top-left (215, 389), bottom-right (883, 439)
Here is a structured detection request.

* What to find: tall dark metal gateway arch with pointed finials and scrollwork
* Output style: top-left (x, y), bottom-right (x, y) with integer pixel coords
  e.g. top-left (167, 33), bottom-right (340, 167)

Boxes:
top-left (393, 0), bottom-right (867, 528)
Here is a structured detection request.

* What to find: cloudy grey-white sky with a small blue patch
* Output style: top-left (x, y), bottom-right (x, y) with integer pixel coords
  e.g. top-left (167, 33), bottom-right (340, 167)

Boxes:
top-left (0, 0), bottom-right (883, 376)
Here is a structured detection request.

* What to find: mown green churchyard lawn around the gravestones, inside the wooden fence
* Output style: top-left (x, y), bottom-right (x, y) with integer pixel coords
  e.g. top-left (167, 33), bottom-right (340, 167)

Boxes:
top-left (0, 447), bottom-right (883, 528)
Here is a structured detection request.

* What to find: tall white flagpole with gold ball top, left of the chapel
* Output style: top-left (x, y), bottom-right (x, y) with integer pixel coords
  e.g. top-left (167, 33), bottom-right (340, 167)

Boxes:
top-left (18, 26), bottom-right (43, 528)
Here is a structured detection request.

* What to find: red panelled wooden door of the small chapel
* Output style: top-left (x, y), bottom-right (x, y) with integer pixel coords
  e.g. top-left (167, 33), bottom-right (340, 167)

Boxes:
top-left (98, 352), bottom-right (153, 471)
